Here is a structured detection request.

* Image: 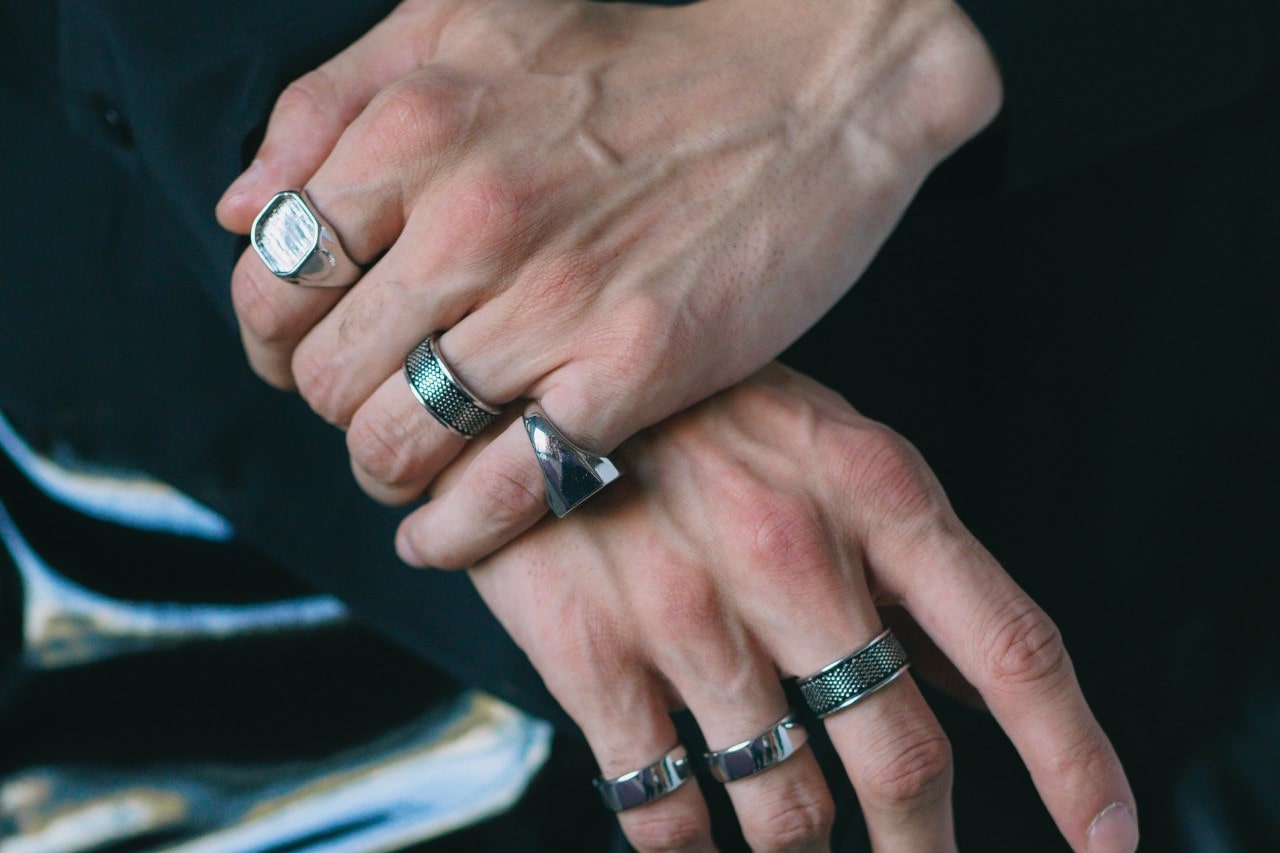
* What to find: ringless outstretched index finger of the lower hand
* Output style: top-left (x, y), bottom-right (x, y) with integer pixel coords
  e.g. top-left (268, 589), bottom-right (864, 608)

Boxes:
top-left (879, 521), bottom-right (1138, 853)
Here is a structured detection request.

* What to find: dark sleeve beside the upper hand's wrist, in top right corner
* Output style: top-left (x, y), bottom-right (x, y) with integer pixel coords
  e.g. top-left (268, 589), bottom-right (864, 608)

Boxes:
top-left (959, 0), bottom-right (1277, 187)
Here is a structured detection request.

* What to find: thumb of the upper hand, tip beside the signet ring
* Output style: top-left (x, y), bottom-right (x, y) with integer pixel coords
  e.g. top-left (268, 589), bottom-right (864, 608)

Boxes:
top-left (216, 2), bottom-right (440, 234)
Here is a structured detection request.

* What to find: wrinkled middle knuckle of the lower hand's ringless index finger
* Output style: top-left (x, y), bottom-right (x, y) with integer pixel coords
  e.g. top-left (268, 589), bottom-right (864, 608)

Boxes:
top-left (982, 596), bottom-right (1070, 689)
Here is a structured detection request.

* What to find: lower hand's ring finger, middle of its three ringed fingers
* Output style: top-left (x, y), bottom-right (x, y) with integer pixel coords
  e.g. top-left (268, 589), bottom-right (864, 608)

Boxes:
top-left (650, 607), bottom-right (835, 850)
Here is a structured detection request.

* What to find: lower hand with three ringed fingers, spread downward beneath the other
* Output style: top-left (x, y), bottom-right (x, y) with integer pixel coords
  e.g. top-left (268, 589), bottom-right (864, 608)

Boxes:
top-left (438, 366), bottom-right (1137, 853)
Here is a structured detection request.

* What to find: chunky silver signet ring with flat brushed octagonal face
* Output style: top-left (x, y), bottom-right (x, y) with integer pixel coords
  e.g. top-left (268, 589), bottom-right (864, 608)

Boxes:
top-left (250, 190), bottom-right (361, 287)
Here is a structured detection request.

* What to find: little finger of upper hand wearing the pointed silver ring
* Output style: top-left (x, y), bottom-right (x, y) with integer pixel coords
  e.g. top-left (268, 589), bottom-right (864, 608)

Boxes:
top-left (396, 419), bottom-right (547, 569)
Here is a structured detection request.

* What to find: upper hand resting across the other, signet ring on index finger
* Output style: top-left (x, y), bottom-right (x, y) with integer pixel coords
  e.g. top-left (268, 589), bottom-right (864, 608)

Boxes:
top-left (218, 0), bottom-right (1001, 566)
